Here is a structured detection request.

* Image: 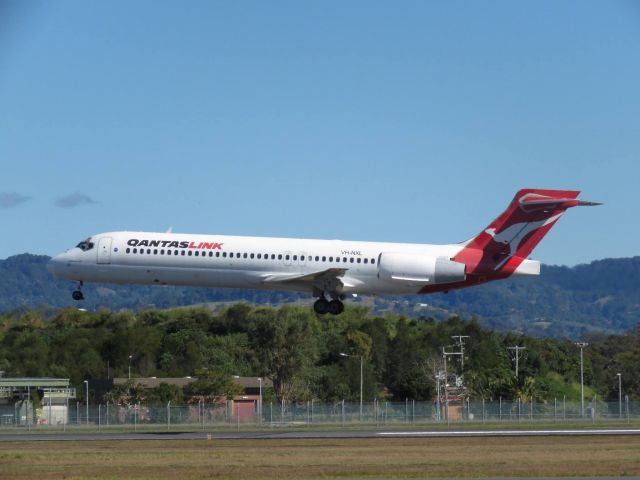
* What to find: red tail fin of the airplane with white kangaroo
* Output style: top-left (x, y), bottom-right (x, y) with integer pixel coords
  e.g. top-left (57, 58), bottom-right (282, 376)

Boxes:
top-left (453, 189), bottom-right (598, 276)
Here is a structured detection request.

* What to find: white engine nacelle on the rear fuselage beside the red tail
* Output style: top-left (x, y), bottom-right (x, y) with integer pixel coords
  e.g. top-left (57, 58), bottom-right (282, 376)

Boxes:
top-left (378, 252), bottom-right (467, 285)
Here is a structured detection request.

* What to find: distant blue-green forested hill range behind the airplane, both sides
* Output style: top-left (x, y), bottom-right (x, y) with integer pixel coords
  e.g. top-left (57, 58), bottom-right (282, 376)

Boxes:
top-left (0, 254), bottom-right (640, 339)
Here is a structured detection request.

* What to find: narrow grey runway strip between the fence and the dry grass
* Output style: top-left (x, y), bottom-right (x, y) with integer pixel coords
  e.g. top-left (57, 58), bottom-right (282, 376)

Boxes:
top-left (0, 428), bottom-right (640, 442)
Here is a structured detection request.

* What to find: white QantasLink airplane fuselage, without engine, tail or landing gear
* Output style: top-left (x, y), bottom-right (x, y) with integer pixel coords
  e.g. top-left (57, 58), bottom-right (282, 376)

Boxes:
top-left (49, 232), bottom-right (463, 294)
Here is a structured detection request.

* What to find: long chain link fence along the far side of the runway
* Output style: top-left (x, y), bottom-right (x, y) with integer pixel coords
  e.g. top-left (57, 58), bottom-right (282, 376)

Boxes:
top-left (0, 397), bottom-right (640, 431)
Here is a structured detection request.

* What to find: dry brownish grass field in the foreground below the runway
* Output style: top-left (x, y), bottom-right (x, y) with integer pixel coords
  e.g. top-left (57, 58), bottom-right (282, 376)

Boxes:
top-left (0, 436), bottom-right (640, 479)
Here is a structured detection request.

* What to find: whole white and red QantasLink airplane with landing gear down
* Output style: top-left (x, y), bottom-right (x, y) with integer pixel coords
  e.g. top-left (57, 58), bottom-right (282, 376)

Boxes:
top-left (47, 189), bottom-right (600, 315)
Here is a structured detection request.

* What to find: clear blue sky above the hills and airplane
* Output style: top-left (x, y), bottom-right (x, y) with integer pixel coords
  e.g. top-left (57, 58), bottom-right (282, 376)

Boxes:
top-left (0, 0), bottom-right (640, 265)
